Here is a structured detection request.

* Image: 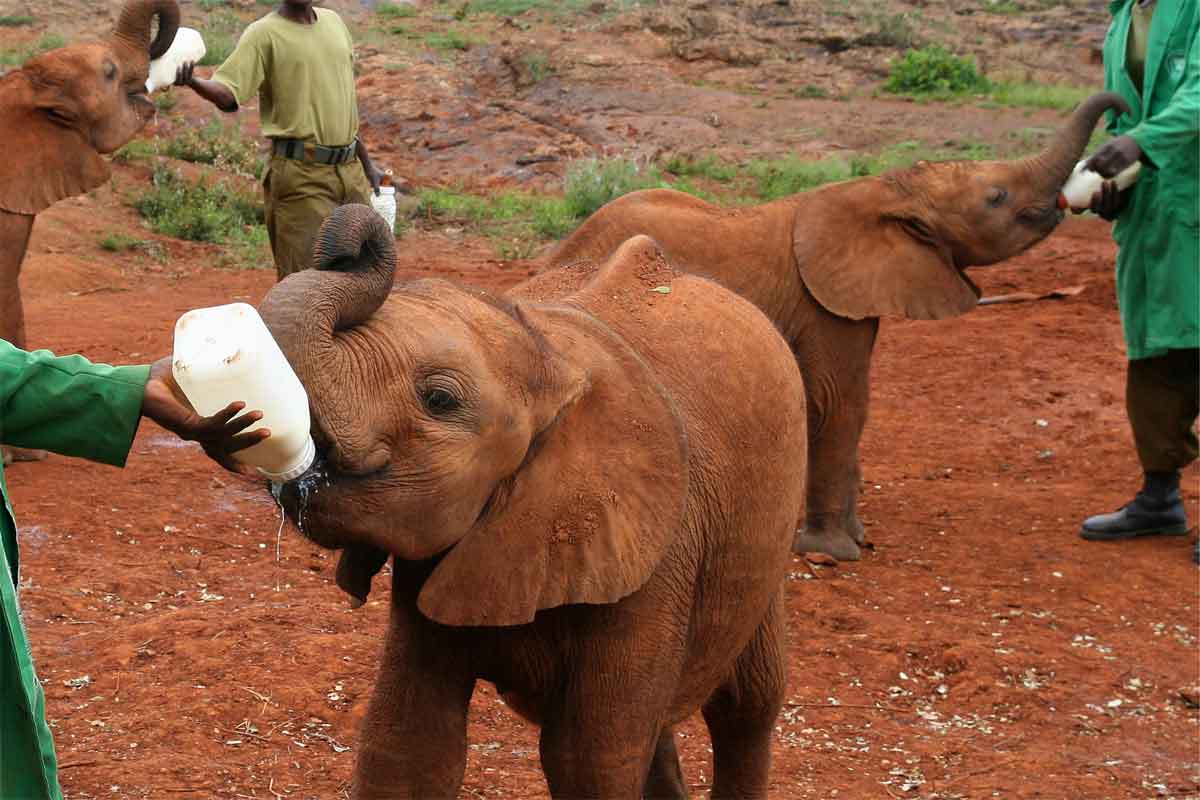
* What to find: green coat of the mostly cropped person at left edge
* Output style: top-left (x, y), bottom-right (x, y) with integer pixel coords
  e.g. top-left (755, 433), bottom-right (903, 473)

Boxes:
top-left (0, 339), bottom-right (150, 800)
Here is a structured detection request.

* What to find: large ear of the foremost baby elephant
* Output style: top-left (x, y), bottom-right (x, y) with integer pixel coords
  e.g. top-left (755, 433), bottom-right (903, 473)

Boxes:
top-left (418, 291), bottom-right (688, 626)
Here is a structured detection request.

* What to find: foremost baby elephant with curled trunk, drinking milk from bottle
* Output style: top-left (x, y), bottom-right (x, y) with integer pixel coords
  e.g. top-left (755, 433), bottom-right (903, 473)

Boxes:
top-left (262, 205), bottom-right (805, 800)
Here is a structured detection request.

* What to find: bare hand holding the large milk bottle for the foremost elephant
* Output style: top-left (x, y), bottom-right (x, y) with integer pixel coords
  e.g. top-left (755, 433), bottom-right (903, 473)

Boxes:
top-left (142, 357), bottom-right (271, 475)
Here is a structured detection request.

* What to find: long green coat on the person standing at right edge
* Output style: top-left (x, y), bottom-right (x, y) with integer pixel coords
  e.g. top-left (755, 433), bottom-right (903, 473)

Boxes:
top-left (1104, 0), bottom-right (1200, 359)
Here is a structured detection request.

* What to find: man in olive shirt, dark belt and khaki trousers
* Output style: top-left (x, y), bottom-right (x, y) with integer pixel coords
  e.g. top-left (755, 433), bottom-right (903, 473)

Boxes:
top-left (175, 0), bottom-right (383, 279)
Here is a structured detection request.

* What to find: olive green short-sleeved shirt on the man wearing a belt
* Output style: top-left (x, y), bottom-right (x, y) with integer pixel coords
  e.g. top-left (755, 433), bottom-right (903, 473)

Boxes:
top-left (212, 8), bottom-right (359, 148)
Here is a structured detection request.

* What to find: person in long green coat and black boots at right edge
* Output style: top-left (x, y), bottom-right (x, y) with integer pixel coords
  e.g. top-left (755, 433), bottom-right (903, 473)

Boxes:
top-left (1080, 0), bottom-right (1200, 561)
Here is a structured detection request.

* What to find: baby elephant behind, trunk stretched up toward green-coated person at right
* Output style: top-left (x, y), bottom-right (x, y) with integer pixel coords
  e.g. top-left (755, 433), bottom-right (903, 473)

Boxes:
top-left (542, 92), bottom-right (1128, 560)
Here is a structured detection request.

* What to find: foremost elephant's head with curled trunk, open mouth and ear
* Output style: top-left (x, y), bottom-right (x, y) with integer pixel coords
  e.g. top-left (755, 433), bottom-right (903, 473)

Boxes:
top-left (260, 205), bottom-right (688, 625)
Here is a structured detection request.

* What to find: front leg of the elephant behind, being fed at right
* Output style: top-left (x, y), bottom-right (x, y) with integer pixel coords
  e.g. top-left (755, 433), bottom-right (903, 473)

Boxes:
top-left (792, 315), bottom-right (878, 561)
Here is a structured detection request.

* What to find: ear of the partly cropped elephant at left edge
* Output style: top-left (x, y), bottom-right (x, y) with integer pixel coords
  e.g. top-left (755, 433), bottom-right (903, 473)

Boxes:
top-left (0, 74), bottom-right (110, 215)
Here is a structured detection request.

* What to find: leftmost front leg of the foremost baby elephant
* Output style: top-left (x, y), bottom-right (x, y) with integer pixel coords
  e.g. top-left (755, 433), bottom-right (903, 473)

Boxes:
top-left (350, 604), bottom-right (475, 800)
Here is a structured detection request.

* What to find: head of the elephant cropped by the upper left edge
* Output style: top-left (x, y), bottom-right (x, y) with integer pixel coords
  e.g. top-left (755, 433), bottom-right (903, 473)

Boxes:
top-left (0, 0), bottom-right (179, 215)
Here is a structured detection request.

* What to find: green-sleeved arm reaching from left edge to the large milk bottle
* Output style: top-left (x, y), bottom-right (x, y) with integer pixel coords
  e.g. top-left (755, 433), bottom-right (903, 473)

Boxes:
top-left (0, 339), bottom-right (269, 471)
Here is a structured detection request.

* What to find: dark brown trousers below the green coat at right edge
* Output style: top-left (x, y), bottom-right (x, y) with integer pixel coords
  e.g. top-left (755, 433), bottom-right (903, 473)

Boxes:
top-left (1126, 349), bottom-right (1200, 473)
